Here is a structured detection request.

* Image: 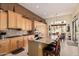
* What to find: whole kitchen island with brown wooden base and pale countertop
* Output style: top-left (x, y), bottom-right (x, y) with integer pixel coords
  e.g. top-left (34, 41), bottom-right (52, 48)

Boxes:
top-left (28, 38), bottom-right (54, 56)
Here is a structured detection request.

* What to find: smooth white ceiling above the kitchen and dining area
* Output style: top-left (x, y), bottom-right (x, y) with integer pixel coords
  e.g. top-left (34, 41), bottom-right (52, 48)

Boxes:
top-left (20, 3), bottom-right (77, 19)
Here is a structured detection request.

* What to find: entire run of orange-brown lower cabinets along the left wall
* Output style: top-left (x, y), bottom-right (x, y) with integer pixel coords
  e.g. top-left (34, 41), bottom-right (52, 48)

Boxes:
top-left (0, 37), bottom-right (25, 55)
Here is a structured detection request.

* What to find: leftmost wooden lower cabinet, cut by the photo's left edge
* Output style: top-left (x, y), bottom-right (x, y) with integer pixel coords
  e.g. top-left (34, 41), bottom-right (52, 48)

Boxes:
top-left (0, 39), bottom-right (10, 55)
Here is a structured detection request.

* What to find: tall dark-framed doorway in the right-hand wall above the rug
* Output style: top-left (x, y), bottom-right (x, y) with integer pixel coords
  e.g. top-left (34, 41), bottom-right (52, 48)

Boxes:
top-left (72, 16), bottom-right (79, 43)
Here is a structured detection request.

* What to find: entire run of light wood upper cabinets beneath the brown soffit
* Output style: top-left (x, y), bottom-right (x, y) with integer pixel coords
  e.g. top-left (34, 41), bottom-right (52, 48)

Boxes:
top-left (0, 10), bottom-right (46, 31)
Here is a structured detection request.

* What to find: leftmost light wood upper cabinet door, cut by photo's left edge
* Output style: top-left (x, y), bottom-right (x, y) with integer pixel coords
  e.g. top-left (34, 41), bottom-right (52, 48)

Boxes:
top-left (0, 10), bottom-right (7, 30)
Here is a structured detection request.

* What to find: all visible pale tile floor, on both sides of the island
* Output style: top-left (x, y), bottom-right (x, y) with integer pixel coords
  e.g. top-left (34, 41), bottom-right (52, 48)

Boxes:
top-left (6, 40), bottom-right (79, 56)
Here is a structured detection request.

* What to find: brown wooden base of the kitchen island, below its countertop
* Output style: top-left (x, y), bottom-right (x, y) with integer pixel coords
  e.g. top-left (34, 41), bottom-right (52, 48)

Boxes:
top-left (28, 40), bottom-right (47, 56)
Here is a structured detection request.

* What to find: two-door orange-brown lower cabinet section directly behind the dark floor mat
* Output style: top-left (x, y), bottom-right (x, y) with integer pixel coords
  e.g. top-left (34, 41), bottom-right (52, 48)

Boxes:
top-left (10, 37), bottom-right (24, 51)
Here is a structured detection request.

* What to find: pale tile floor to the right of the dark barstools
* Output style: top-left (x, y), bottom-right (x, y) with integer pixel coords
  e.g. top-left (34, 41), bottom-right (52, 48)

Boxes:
top-left (60, 40), bottom-right (79, 56)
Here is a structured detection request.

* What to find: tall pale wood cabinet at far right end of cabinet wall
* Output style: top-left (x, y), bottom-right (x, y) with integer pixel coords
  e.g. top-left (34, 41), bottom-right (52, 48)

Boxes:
top-left (34, 21), bottom-right (48, 37)
